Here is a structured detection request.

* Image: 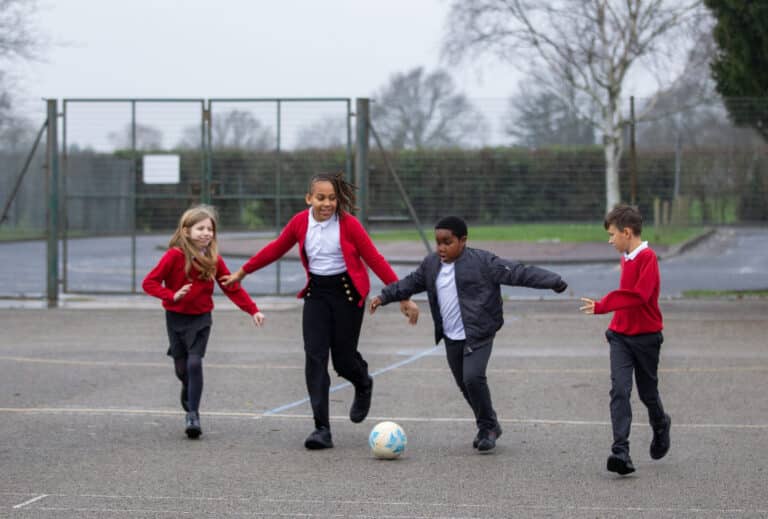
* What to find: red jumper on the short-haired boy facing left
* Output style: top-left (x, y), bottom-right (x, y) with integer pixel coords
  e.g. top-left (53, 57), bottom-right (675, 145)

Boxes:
top-left (595, 248), bottom-right (664, 335)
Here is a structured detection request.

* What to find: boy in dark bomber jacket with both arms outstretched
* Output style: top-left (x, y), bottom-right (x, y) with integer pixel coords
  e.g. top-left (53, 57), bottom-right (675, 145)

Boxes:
top-left (370, 216), bottom-right (568, 453)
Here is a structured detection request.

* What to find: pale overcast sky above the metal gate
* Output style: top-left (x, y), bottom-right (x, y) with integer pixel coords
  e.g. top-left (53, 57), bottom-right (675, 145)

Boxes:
top-left (19, 0), bottom-right (518, 111)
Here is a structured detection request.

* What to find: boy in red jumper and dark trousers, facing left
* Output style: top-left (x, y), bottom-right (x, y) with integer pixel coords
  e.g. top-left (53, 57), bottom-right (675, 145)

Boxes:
top-left (580, 205), bottom-right (672, 476)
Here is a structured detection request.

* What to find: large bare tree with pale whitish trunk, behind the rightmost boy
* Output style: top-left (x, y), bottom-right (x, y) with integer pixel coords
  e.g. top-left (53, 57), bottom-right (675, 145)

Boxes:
top-left (444, 0), bottom-right (700, 211)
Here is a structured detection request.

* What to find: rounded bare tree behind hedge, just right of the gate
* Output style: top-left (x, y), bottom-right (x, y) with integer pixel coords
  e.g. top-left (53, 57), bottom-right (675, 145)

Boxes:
top-left (371, 67), bottom-right (486, 149)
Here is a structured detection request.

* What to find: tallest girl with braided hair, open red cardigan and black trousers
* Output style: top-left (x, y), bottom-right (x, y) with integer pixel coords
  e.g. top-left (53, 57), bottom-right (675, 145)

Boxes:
top-left (222, 173), bottom-right (419, 449)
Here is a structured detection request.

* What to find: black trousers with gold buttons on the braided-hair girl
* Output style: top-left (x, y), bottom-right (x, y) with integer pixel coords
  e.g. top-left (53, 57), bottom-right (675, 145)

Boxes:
top-left (302, 272), bottom-right (370, 428)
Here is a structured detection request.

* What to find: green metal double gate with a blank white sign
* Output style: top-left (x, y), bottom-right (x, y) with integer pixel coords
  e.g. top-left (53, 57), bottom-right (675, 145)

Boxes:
top-left (60, 98), bottom-right (352, 294)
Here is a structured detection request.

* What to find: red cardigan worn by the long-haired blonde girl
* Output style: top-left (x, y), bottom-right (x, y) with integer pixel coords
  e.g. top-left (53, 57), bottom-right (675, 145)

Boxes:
top-left (141, 247), bottom-right (259, 315)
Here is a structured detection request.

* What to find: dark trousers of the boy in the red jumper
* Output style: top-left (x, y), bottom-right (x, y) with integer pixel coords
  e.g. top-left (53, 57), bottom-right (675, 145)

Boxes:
top-left (605, 330), bottom-right (665, 455)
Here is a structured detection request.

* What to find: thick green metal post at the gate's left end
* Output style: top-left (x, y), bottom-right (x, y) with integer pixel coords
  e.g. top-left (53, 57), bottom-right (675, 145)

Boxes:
top-left (45, 99), bottom-right (59, 307)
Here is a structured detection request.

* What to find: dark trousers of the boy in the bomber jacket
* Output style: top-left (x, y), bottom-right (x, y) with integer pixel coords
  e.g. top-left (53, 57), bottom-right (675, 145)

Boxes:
top-left (443, 337), bottom-right (497, 430)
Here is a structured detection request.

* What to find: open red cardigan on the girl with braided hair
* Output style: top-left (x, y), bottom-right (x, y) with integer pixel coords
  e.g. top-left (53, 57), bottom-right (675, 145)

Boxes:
top-left (242, 209), bottom-right (397, 306)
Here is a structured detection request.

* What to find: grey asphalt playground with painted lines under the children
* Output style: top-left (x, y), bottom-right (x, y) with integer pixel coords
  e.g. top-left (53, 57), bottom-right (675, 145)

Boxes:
top-left (0, 298), bottom-right (768, 519)
